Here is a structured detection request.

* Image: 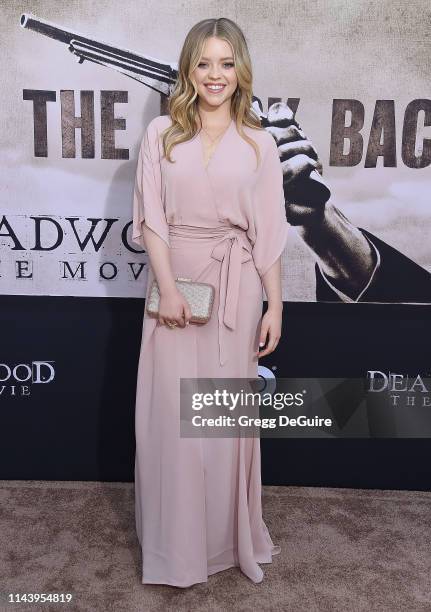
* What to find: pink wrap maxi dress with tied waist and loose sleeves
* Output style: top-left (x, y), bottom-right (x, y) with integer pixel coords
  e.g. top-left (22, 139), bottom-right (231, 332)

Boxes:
top-left (132, 115), bottom-right (289, 587)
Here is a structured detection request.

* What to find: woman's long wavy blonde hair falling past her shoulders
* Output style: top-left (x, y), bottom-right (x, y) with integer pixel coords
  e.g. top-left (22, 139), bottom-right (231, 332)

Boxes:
top-left (162, 17), bottom-right (264, 170)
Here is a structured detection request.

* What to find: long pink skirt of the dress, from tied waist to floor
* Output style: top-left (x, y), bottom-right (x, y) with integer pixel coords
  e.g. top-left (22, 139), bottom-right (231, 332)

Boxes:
top-left (135, 225), bottom-right (280, 587)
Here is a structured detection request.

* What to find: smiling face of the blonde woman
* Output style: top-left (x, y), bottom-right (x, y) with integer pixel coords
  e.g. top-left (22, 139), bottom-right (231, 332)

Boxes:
top-left (192, 36), bottom-right (238, 110)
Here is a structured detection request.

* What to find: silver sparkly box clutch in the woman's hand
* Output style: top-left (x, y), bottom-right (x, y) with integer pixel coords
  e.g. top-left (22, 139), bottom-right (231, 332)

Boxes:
top-left (146, 276), bottom-right (215, 324)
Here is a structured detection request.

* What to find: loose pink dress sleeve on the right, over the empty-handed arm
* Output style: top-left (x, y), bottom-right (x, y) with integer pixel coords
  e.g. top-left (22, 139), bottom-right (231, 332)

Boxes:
top-left (249, 134), bottom-right (289, 277)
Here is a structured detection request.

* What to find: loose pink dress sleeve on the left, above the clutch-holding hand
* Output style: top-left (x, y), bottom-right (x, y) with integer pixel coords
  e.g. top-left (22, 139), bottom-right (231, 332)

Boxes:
top-left (132, 119), bottom-right (169, 250)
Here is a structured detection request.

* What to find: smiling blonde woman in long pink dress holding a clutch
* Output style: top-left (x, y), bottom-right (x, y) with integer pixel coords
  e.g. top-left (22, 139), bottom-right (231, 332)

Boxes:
top-left (132, 19), bottom-right (288, 587)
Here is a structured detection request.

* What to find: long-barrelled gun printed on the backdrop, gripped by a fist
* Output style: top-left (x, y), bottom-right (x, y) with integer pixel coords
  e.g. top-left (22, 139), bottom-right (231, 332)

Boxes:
top-left (20, 13), bottom-right (331, 203)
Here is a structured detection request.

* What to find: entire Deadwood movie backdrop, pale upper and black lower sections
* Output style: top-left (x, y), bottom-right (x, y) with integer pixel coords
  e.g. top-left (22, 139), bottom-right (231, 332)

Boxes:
top-left (0, 0), bottom-right (431, 489)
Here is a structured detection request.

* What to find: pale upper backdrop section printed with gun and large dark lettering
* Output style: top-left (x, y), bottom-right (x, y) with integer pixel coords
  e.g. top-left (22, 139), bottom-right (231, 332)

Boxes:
top-left (0, 0), bottom-right (431, 303)
